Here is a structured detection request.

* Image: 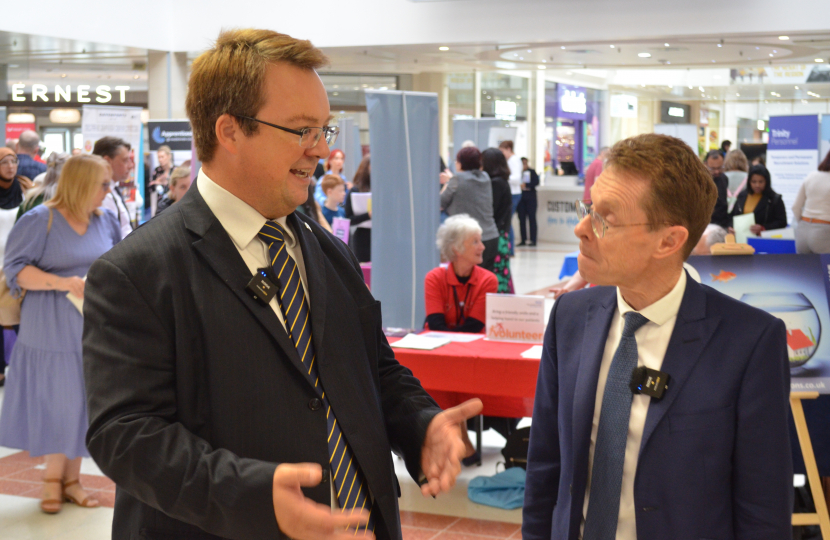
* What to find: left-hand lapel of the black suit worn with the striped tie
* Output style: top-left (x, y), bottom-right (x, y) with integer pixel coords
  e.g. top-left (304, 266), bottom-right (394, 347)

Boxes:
top-left (177, 189), bottom-right (307, 380)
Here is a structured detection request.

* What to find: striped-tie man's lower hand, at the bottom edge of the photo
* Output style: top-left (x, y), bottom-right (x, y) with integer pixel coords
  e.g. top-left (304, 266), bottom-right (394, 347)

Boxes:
top-left (273, 463), bottom-right (374, 540)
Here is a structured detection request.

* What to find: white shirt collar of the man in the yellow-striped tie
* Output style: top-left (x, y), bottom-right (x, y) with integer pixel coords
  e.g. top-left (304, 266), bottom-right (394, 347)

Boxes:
top-left (196, 169), bottom-right (297, 249)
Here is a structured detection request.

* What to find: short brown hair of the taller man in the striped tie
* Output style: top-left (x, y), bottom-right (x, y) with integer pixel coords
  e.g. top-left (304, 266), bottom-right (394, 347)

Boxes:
top-left (185, 29), bottom-right (328, 163)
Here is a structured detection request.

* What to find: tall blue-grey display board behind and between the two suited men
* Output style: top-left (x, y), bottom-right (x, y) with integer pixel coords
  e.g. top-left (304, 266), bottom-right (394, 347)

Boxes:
top-left (365, 90), bottom-right (440, 328)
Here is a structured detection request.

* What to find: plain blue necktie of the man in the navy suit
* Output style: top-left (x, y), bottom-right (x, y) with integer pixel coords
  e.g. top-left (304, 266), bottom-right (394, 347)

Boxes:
top-left (582, 311), bottom-right (648, 540)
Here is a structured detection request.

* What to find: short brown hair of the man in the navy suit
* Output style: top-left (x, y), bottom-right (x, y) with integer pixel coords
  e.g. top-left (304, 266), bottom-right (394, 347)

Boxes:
top-left (606, 133), bottom-right (718, 260)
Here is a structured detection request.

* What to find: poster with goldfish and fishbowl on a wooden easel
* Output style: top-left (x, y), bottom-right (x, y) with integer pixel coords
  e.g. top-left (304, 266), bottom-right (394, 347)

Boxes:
top-left (688, 255), bottom-right (830, 394)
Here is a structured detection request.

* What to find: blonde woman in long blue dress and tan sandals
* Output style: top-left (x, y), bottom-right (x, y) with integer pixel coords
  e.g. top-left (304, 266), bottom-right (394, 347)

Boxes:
top-left (0, 155), bottom-right (121, 514)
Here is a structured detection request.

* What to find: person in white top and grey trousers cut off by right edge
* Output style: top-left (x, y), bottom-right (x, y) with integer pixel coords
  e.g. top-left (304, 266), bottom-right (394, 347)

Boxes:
top-left (793, 152), bottom-right (830, 254)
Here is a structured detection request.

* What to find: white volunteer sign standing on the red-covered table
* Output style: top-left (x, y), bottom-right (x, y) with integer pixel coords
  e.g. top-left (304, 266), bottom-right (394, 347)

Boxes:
top-left (484, 294), bottom-right (545, 343)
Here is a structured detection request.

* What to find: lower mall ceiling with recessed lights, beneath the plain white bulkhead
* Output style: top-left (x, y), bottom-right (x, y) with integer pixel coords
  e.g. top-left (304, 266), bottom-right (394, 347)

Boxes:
top-left (0, 27), bottom-right (830, 100)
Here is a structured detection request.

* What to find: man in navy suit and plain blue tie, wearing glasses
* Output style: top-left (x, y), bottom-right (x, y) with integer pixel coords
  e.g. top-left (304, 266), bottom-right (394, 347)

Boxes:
top-left (522, 134), bottom-right (793, 540)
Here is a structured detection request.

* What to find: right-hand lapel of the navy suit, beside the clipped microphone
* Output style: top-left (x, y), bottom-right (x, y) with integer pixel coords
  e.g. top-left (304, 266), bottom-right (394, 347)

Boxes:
top-left (640, 275), bottom-right (721, 454)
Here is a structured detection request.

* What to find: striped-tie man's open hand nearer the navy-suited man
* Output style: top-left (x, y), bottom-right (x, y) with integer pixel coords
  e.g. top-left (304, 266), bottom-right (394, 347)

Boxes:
top-left (421, 398), bottom-right (484, 497)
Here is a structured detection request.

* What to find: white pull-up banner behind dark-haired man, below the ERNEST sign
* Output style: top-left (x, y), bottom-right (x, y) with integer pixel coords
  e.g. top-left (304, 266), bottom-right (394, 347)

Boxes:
top-left (81, 105), bottom-right (144, 223)
